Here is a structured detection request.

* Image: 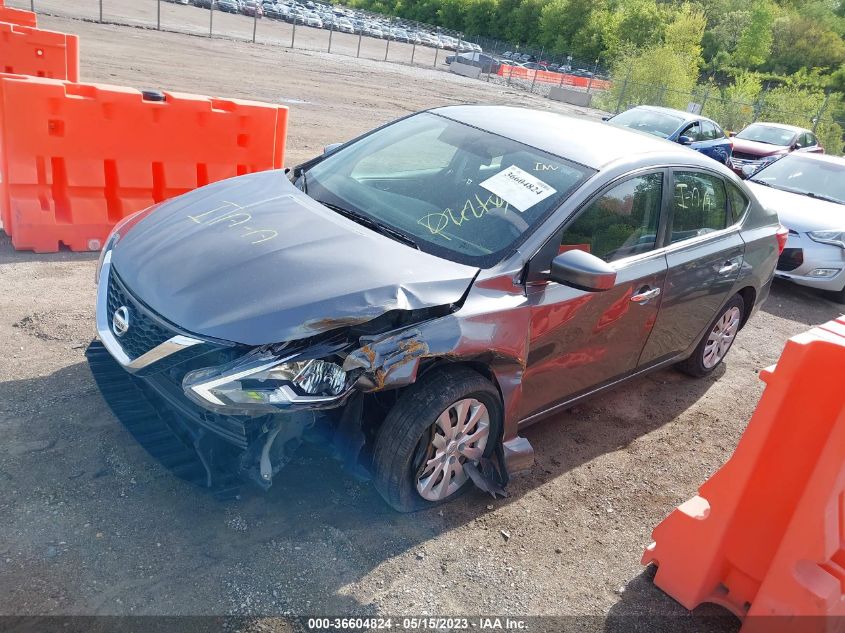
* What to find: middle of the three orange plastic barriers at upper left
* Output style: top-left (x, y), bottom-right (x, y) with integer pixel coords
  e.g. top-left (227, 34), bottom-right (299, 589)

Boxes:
top-left (0, 22), bottom-right (79, 81)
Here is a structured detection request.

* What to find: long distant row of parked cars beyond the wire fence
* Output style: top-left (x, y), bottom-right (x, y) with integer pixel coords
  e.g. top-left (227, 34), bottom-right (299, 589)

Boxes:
top-left (178, 0), bottom-right (482, 53)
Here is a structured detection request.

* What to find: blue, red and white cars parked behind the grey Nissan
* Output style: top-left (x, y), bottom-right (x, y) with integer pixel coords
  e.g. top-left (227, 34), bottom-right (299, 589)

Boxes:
top-left (606, 106), bottom-right (845, 303)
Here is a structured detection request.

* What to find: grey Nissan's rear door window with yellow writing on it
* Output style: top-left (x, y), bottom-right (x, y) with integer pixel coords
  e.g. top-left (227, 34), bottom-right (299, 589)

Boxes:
top-left (670, 171), bottom-right (728, 244)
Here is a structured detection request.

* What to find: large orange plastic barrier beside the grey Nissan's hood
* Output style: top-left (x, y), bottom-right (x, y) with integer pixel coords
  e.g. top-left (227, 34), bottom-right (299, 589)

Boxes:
top-left (0, 76), bottom-right (287, 252)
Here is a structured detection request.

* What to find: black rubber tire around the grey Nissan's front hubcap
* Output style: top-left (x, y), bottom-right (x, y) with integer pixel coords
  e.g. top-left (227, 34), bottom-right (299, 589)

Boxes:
top-left (373, 365), bottom-right (502, 512)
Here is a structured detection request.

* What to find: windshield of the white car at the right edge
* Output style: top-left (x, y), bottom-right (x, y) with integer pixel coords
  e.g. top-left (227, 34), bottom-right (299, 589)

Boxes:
top-left (750, 154), bottom-right (845, 204)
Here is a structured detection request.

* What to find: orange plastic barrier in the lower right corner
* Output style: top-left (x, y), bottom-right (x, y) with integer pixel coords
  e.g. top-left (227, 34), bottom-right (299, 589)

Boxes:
top-left (643, 317), bottom-right (845, 633)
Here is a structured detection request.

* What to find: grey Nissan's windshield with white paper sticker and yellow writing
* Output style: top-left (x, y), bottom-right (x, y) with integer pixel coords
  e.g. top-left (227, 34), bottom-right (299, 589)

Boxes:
top-left (303, 113), bottom-right (594, 267)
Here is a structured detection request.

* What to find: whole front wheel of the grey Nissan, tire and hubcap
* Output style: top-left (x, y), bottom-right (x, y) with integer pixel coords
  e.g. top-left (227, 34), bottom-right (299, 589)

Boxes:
top-left (373, 367), bottom-right (502, 512)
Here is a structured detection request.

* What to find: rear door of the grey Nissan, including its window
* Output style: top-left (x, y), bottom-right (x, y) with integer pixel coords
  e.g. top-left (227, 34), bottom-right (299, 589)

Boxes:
top-left (639, 168), bottom-right (745, 367)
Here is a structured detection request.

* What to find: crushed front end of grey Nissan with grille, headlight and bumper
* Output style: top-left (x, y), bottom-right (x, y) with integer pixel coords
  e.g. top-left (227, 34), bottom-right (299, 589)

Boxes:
top-left (86, 246), bottom-right (362, 497)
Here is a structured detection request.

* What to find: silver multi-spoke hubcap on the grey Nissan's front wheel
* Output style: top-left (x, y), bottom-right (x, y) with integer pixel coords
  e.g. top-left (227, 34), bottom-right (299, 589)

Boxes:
top-left (417, 398), bottom-right (490, 501)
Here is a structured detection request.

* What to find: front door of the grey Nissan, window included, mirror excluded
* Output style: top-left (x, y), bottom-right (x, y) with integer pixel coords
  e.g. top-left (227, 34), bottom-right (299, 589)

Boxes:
top-left (520, 171), bottom-right (666, 417)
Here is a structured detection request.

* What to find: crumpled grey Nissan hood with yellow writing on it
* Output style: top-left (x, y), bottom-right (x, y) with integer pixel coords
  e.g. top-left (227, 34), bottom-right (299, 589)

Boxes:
top-left (112, 171), bottom-right (478, 345)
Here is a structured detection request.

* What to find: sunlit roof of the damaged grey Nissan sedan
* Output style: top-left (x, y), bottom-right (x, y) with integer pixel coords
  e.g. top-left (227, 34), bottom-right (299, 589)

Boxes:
top-left (431, 105), bottom-right (715, 170)
